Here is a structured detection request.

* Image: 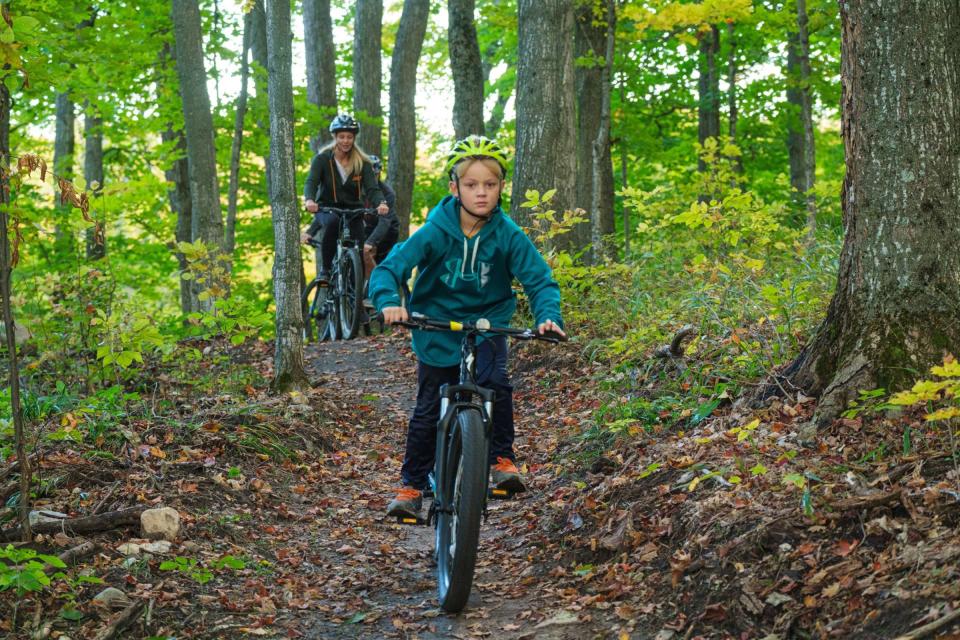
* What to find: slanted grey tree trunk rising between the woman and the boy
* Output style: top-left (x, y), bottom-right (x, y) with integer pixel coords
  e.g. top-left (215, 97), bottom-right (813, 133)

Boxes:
top-left (387, 0), bottom-right (430, 240)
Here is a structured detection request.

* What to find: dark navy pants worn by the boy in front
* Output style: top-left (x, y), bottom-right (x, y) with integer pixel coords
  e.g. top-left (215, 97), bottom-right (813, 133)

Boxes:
top-left (400, 336), bottom-right (514, 489)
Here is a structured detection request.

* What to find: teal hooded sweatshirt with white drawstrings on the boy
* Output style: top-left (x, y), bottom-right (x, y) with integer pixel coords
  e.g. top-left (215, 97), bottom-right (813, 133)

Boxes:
top-left (370, 196), bottom-right (563, 367)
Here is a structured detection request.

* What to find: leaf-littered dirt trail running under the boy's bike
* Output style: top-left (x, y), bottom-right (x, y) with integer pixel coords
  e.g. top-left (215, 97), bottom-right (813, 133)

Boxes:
top-left (290, 336), bottom-right (615, 640)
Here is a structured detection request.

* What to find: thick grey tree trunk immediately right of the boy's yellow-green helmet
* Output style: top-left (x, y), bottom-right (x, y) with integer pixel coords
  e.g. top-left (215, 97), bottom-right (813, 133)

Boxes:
top-left (510, 0), bottom-right (576, 234)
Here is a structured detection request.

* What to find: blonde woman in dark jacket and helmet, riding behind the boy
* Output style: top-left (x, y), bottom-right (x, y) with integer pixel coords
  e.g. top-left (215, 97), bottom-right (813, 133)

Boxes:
top-left (300, 114), bottom-right (390, 282)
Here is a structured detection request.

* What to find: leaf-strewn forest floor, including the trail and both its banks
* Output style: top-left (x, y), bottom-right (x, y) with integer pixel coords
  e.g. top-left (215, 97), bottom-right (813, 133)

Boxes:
top-left (0, 328), bottom-right (960, 640)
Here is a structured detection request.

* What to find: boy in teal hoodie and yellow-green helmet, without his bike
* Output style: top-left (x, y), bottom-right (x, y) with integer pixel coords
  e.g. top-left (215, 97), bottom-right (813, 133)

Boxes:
top-left (370, 136), bottom-right (564, 517)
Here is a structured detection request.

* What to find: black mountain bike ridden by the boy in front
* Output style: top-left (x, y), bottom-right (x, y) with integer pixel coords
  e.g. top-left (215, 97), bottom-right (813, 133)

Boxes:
top-left (399, 313), bottom-right (564, 613)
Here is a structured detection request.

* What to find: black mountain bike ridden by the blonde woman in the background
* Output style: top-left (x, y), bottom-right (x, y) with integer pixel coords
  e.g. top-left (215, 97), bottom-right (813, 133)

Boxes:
top-left (301, 207), bottom-right (377, 341)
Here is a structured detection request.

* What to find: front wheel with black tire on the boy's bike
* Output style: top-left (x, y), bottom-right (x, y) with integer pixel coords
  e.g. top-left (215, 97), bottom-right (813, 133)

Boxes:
top-left (436, 409), bottom-right (487, 613)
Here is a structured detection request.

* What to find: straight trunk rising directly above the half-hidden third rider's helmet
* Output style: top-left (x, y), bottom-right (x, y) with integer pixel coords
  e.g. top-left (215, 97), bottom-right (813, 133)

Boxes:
top-left (353, 0), bottom-right (383, 156)
